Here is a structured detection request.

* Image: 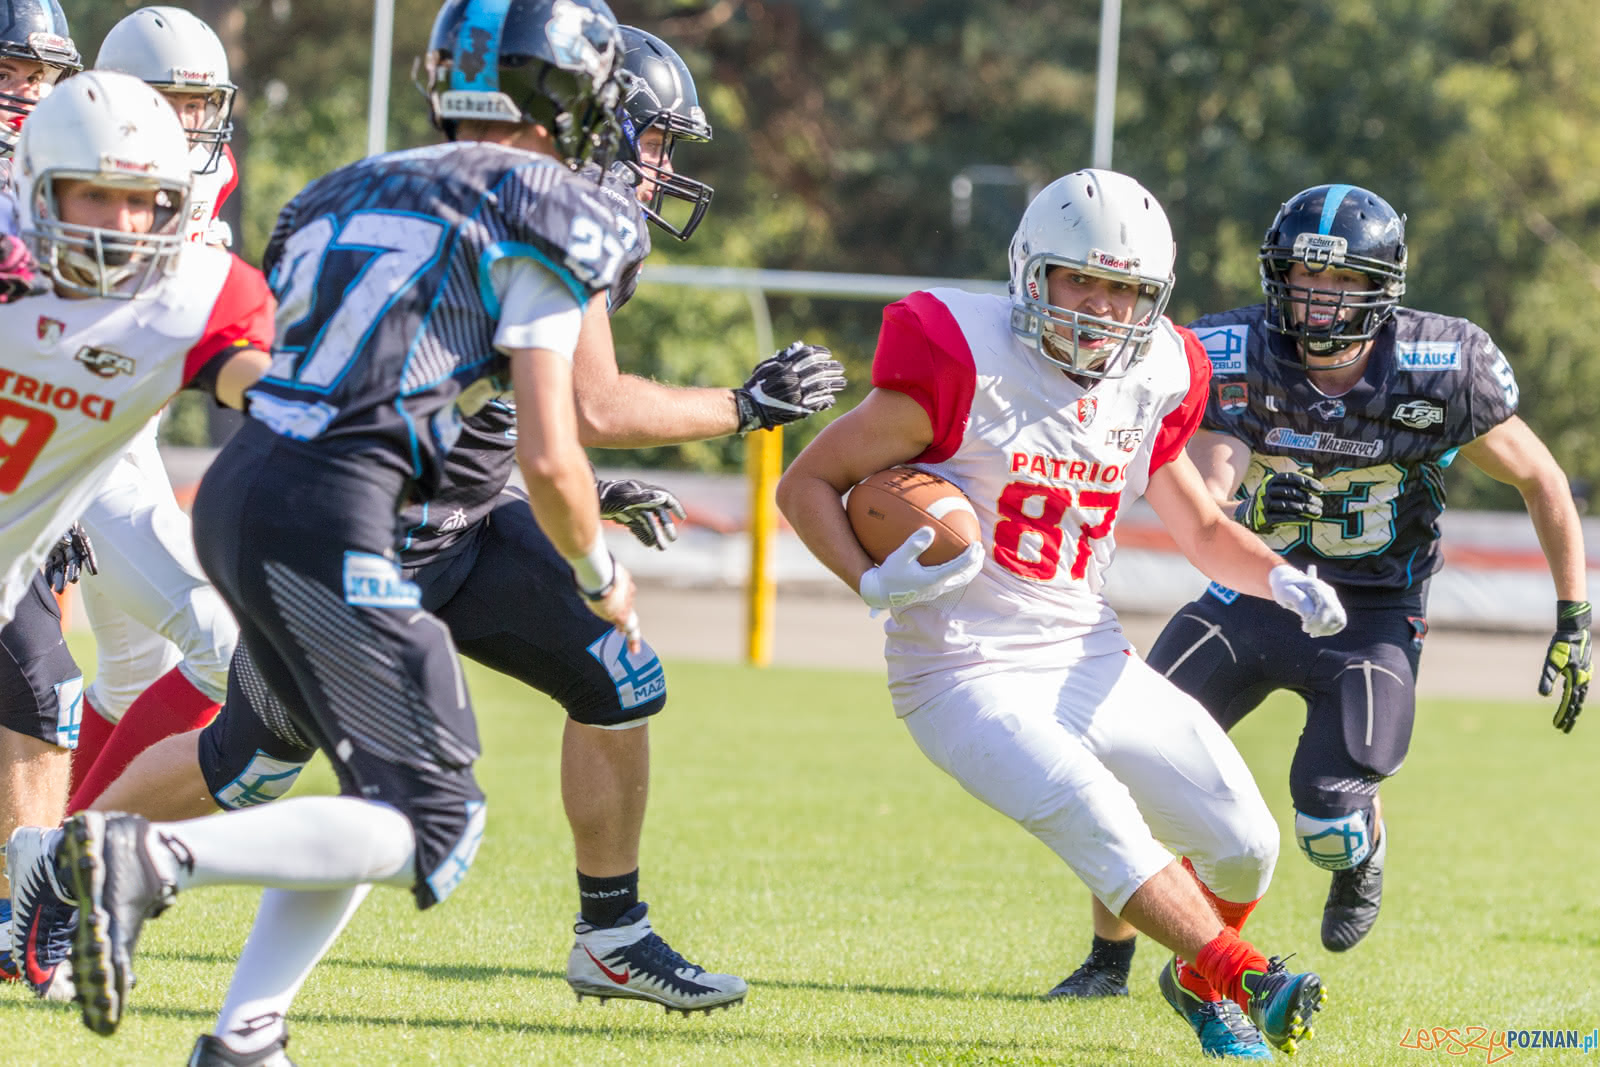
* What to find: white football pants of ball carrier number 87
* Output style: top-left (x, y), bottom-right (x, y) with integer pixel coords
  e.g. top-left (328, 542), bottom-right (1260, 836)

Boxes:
top-left (896, 653), bottom-right (1278, 915)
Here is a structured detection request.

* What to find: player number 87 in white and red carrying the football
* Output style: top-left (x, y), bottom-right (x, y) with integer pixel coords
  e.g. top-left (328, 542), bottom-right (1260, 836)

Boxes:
top-left (778, 170), bottom-right (1344, 1057)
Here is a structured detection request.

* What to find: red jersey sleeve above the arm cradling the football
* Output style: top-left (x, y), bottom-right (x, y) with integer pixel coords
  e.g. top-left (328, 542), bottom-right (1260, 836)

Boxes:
top-left (872, 293), bottom-right (979, 462)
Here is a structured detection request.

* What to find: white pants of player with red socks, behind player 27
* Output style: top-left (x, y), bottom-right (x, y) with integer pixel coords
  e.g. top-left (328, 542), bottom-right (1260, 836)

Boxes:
top-left (78, 416), bottom-right (238, 721)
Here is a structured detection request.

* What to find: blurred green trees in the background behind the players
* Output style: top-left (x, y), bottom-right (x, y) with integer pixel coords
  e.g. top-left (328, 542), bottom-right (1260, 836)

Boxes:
top-left (81, 0), bottom-right (1600, 507)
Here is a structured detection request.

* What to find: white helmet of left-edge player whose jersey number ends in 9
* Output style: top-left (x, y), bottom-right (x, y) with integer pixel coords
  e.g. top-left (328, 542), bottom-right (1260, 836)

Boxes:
top-left (11, 70), bottom-right (194, 299)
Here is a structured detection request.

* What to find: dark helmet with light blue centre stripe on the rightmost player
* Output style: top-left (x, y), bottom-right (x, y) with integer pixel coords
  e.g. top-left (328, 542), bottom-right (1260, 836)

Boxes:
top-left (1261, 186), bottom-right (1405, 370)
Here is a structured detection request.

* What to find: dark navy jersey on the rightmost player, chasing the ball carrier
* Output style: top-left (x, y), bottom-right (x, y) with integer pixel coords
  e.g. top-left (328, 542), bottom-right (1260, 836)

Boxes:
top-left (1190, 304), bottom-right (1517, 590)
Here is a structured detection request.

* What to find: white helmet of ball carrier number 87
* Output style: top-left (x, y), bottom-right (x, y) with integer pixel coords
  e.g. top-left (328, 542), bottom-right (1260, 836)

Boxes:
top-left (1011, 170), bottom-right (1178, 378)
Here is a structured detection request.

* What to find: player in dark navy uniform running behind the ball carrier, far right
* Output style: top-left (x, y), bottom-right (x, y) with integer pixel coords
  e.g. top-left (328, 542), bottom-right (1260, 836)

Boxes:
top-left (1058, 184), bottom-right (1590, 997)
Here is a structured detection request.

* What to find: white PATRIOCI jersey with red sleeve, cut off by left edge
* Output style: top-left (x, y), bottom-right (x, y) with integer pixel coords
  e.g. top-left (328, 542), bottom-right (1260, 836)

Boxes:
top-left (0, 245), bottom-right (272, 622)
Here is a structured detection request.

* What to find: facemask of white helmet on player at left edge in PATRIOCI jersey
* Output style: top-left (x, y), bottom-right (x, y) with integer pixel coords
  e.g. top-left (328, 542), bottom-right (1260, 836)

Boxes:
top-left (33, 170), bottom-right (189, 299)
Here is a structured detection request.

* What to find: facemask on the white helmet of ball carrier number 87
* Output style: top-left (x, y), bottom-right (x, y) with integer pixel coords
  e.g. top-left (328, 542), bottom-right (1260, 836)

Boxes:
top-left (1011, 251), bottom-right (1173, 378)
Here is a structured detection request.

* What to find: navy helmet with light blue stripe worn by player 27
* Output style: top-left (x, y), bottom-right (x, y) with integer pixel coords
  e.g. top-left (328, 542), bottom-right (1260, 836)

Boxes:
top-left (421, 0), bottom-right (622, 165)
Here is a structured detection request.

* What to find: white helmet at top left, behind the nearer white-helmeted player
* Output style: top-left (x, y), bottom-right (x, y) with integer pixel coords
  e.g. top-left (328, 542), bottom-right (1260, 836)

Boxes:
top-left (94, 8), bottom-right (238, 174)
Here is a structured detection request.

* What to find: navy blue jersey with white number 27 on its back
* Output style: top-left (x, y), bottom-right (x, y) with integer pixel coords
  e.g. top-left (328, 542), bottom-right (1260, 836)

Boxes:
top-left (250, 141), bottom-right (642, 498)
